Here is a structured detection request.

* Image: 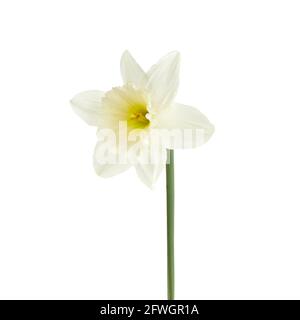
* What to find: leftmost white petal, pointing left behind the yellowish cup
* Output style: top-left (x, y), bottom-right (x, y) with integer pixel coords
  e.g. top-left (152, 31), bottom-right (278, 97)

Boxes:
top-left (71, 90), bottom-right (104, 126)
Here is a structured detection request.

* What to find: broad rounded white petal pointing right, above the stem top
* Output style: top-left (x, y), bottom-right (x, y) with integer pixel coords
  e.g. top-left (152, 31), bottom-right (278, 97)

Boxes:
top-left (156, 103), bottom-right (214, 149)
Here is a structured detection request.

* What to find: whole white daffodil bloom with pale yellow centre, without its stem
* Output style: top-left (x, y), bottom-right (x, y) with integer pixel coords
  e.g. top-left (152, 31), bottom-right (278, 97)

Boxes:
top-left (71, 51), bottom-right (214, 186)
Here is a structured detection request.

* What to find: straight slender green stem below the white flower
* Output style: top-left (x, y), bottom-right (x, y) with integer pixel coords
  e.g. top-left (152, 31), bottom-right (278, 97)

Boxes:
top-left (166, 150), bottom-right (175, 300)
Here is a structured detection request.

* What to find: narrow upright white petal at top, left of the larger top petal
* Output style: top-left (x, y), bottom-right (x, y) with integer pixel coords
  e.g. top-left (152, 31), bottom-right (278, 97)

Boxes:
top-left (121, 51), bottom-right (147, 88)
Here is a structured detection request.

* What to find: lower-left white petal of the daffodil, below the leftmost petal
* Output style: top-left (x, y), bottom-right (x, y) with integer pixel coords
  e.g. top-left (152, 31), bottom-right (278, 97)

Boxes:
top-left (94, 141), bottom-right (131, 178)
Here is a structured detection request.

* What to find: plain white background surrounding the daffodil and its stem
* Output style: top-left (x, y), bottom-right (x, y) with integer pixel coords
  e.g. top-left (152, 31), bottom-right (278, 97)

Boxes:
top-left (0, 0), bottom-right (300, 299)
